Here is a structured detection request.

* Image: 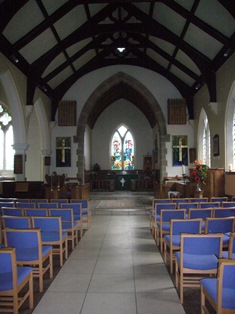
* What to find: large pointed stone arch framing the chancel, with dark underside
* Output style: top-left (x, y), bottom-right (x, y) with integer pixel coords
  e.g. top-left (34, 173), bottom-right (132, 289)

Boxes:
top-left (76, 72), bottom-right (170, 181)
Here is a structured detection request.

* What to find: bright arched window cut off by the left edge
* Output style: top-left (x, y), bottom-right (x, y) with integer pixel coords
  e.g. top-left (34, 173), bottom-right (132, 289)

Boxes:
top-left (0, 104), bottom-right (14, 176)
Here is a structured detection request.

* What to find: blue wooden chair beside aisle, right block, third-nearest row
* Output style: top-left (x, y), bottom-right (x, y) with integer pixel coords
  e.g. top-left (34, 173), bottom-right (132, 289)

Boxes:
top-left (164, 218), bottom-right (202, 273)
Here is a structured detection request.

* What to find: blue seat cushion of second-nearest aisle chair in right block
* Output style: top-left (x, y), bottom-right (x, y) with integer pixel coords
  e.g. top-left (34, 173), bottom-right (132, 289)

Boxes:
top-left (175, 252), bottom-right (218, 270)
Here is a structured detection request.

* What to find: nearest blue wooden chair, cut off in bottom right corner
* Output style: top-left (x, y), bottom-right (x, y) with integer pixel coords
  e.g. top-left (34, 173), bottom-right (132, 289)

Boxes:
top-left (200, 259), bottom-right (235, 314)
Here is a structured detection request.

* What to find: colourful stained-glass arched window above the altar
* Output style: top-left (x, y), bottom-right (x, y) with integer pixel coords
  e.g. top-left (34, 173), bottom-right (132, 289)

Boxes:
top-left (111, 125), bottom-right (135, 170)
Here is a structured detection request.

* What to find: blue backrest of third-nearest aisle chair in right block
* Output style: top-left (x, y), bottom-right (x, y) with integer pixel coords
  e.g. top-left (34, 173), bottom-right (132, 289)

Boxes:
top-left (171, 218), bottom-right (202, 235)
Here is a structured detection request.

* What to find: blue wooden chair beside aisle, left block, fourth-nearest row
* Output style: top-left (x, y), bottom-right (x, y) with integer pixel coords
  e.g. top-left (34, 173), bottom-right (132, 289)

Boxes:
top-left (49, 208), bottom-right (79, 249)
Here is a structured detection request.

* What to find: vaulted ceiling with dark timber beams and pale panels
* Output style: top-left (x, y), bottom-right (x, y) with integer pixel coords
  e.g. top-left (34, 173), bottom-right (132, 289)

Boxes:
top-left (0, 0), bottom-right (235, 122)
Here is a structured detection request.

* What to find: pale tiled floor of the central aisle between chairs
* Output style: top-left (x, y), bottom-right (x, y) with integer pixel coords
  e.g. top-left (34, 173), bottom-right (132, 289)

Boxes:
top-left (33, 194), bottom-right (185, 314)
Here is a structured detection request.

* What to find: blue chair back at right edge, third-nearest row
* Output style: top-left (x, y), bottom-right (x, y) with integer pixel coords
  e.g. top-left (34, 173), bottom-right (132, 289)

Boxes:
top-left (205, 217), bottom-right (235, 233)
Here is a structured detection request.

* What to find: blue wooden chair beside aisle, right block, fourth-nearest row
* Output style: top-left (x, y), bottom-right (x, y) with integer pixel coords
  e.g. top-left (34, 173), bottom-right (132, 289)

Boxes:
top-left (155, 209), bottom-right (186, 252)
